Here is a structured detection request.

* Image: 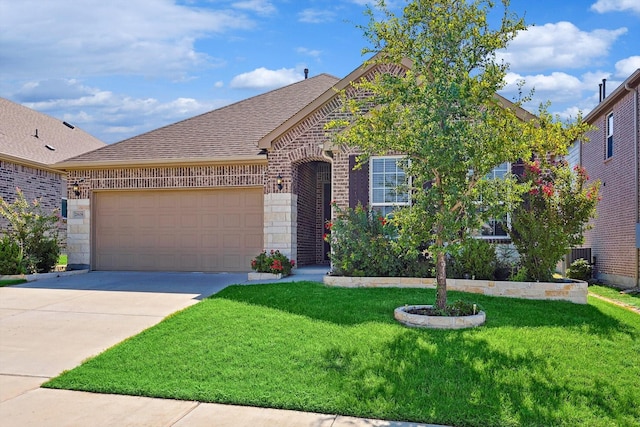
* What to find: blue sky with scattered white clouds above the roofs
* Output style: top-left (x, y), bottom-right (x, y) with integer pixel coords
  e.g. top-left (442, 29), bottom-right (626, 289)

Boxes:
top-left (0, 0), bottom-right (640, 143)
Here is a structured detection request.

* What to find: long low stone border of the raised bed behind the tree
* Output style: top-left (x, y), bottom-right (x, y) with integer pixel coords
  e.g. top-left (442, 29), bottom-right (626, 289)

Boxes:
top-left (324, 276), bottom-right (588, 304)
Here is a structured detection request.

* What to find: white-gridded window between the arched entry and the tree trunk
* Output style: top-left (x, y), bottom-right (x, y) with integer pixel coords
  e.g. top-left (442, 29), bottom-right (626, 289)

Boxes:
top-left (369, 156), bottom-right (411, 216)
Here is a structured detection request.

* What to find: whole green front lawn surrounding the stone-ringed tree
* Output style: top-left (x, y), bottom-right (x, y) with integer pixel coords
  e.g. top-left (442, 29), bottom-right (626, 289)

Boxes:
top-left (45, 282), bottom-right (640, 427)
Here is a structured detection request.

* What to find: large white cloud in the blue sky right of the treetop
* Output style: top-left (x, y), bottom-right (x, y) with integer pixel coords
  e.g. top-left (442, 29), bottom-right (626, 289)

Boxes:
top-left (498, 22), bottom-right (627, 71)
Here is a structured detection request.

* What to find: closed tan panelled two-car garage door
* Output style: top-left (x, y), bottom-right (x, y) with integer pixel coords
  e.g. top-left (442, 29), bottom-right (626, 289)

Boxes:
top-left (93, 189), bottom-right (263, 271)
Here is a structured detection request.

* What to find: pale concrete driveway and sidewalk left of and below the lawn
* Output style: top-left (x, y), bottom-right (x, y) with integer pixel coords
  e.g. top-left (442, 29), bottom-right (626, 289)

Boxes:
top-left (0, 268), bottom-right (442, 427)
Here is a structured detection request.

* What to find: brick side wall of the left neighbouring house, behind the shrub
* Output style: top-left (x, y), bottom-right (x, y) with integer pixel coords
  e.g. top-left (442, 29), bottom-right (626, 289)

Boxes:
top-left (0, 161), bottom-right (67, 250)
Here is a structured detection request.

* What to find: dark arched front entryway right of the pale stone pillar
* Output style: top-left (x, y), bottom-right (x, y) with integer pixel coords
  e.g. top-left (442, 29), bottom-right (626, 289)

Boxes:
top-left (294, 161), bottom-right (331, 266)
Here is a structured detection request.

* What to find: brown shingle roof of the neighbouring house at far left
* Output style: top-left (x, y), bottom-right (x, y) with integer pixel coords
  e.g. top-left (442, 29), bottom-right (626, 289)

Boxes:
top-left (0, 98), bottom-right (105, 165)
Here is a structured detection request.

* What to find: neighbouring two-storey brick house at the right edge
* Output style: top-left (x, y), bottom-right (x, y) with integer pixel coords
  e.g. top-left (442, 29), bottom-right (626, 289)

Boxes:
top-left (568, 69), bottom-right (640, 287)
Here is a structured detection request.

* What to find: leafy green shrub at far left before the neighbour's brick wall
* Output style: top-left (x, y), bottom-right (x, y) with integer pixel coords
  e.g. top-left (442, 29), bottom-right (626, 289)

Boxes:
top-left (0, 188), bottom-right (60, 273)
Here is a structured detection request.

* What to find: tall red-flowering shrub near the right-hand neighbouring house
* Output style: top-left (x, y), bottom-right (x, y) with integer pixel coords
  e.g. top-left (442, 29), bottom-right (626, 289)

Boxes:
top-left (509, 160), bottom-right (600, 281)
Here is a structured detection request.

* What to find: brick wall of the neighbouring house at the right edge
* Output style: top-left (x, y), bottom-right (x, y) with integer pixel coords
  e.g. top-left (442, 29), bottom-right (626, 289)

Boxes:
top-left (582, 86), bottom-right (638, 286)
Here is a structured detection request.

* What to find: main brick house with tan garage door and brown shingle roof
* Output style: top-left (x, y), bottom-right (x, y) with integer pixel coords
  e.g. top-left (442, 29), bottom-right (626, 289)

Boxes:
top-left (56, 59), bottom-right (528, 271)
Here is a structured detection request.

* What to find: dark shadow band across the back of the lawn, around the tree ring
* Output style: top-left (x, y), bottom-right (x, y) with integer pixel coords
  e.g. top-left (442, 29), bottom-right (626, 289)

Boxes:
top-left (218, 282), bottom-right (638, 338)
